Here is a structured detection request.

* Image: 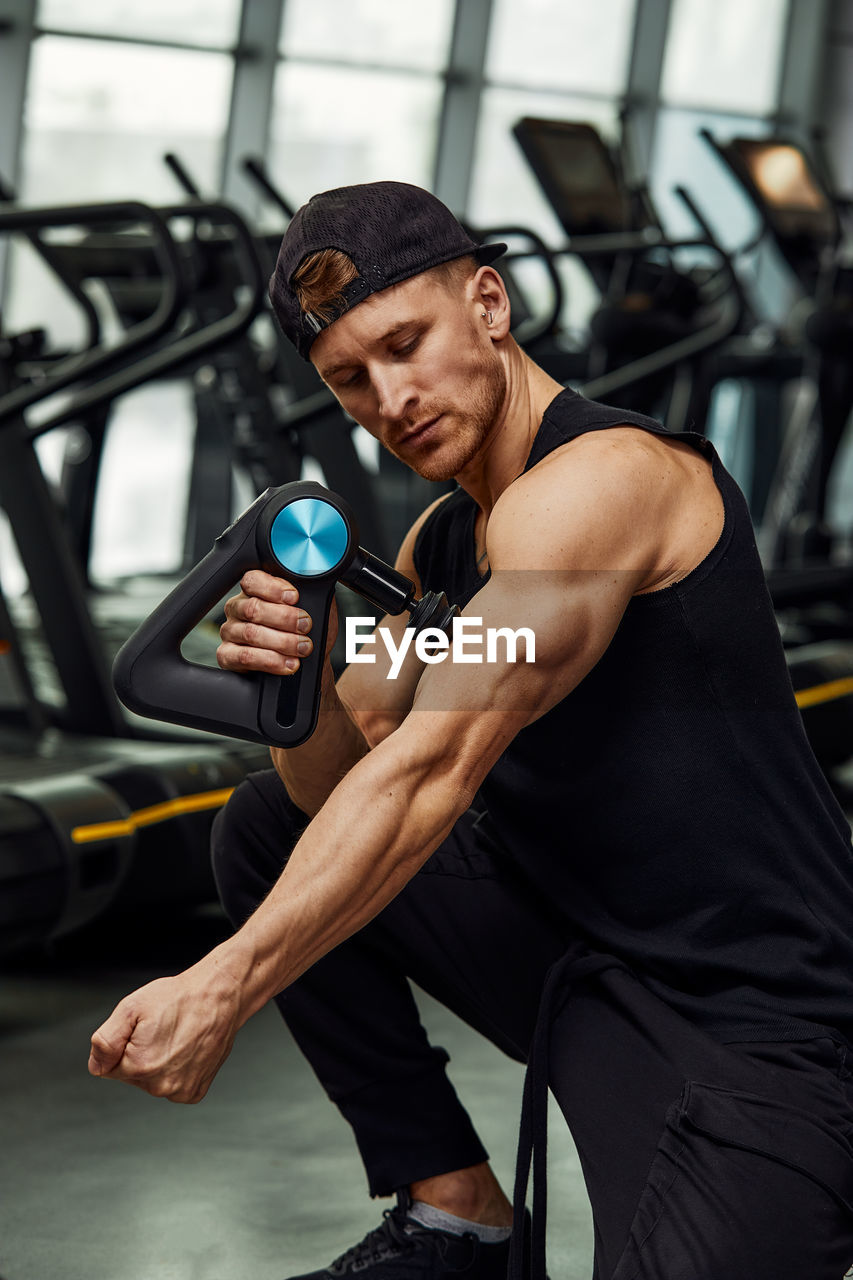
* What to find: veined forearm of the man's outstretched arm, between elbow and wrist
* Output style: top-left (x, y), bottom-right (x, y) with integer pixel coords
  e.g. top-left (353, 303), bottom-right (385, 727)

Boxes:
top-left (229, 739), bottom-right (476, 1023)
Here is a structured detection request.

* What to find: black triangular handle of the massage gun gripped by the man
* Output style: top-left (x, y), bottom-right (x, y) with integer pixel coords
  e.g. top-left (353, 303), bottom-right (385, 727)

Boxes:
top-left (113, 485), bottom-right (343, 746)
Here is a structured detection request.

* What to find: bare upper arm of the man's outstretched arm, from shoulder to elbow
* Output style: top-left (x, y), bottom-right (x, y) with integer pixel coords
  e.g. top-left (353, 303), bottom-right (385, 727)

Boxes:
top-left (348, 442), bottom-right (661, 790)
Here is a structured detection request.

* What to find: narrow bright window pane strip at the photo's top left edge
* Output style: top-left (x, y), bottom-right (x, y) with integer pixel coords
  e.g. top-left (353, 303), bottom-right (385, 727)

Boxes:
top-left (36, 0), bottom-right (240, 49)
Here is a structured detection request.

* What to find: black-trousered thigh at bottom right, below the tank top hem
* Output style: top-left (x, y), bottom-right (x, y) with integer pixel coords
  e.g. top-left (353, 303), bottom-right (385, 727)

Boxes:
top-left (540, 964), bottom-right (853, 1280)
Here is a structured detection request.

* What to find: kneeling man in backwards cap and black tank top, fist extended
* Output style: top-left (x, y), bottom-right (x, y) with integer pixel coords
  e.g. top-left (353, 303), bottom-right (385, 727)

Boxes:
top-left (90, 183), bottom-right (853, 1280)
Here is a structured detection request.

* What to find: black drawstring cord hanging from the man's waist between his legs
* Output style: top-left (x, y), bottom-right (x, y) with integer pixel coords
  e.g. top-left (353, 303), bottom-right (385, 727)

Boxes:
top-left (507, 950), bottom-right (619, 1280)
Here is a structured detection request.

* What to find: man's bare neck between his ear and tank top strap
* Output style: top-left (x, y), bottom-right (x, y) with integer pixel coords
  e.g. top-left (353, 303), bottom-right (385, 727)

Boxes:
top-left (456, 338), bottom-right (564, 517)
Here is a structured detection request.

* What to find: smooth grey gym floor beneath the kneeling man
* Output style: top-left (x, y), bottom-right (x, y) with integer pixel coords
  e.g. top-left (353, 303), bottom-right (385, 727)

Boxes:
top-left (0, 909), bottom-right (592, 1280)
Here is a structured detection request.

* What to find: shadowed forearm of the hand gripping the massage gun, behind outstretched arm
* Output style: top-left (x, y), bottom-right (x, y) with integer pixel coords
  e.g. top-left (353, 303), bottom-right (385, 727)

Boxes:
top-left (270, 659), bottom-right (368, 818)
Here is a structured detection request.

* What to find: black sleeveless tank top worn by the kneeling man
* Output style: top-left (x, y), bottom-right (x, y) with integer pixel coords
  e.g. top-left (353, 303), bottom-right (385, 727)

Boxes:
top-left (415, 390), bottom-right (853, 1042)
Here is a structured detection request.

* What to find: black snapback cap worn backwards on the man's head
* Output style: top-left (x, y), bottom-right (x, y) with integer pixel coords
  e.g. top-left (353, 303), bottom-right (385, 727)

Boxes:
top-left (269, 182), bottom-right (506, 360)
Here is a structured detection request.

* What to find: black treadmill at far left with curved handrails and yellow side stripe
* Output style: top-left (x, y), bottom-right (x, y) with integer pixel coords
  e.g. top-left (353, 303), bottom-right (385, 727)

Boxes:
top-left (0, 202), bottom-right (269, 951)
